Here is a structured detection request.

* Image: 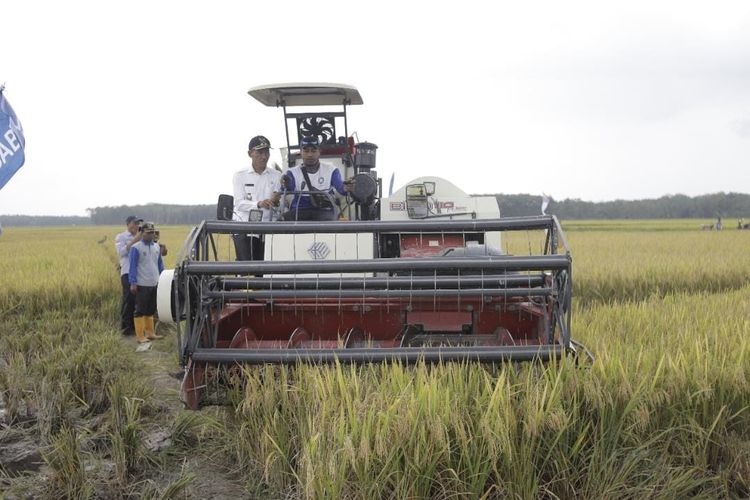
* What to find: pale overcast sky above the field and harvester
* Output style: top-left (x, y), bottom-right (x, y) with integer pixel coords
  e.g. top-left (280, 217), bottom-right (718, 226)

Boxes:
top-left (0, 0), bottom-right (750, 215)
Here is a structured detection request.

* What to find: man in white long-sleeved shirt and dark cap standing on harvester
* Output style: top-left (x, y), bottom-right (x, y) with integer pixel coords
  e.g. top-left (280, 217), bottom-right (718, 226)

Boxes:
top-left (232, 135), bottom-right (281, 260)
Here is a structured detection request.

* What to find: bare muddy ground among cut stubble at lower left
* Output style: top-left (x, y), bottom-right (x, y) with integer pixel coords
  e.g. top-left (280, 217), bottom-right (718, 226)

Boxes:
top-left (0, 326), bottom-right (254, 500)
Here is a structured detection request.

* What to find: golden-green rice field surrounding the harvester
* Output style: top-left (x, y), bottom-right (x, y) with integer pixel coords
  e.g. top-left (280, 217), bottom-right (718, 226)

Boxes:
top-left (0, 221), bottom-right (750, 499)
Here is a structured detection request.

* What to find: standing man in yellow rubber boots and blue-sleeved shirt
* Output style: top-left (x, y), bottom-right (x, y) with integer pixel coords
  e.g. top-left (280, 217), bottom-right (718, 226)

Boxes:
top-left (128, 222), bottom-right (164, 344)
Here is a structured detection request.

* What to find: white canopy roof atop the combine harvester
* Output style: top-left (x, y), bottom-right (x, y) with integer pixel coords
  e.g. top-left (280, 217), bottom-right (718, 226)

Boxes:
top-left (247, 83), bottom-right (362, 106)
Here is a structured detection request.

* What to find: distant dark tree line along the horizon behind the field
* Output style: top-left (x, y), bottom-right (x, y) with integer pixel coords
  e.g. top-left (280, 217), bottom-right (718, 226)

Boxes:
top-left (0, 192), bottom-right (750, 227)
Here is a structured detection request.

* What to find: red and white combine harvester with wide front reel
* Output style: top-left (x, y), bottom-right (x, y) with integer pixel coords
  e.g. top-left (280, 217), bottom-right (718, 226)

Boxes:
top-left (158, 84), bottom-right (577, 409)
